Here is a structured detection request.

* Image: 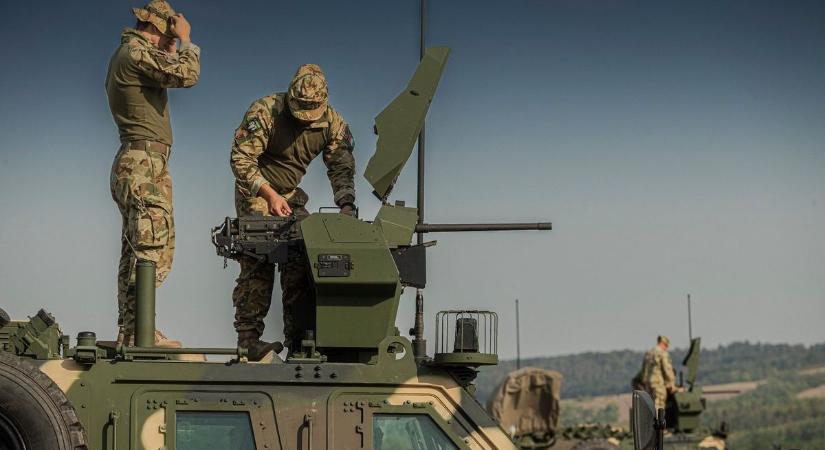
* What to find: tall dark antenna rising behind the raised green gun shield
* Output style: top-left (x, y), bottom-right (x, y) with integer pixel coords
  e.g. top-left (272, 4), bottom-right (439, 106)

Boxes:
top-left (412, 0), bottom-right (427, 361)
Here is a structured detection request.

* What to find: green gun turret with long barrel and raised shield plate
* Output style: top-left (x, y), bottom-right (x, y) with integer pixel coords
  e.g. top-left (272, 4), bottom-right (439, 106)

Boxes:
top-left (213, 47), bottom-right (552, 367)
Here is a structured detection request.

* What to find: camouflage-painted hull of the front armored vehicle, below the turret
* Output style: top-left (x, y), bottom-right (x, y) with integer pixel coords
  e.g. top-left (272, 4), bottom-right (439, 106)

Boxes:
top-left (0, 337), bottom-right (515, 450)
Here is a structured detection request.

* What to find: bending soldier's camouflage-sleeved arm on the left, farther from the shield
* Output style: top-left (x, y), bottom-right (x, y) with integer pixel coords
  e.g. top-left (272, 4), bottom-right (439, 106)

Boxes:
top-left (229, 99), bottom-right (273, 197)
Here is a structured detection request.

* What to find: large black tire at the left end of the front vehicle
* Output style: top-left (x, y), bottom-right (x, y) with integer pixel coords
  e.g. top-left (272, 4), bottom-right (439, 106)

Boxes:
top-left (0, 351), bottom-right (87, 450)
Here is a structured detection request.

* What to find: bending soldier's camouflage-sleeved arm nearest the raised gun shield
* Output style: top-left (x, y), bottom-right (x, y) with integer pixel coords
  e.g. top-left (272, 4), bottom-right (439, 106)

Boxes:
top-left (324, 111), bottom-right (355, 208)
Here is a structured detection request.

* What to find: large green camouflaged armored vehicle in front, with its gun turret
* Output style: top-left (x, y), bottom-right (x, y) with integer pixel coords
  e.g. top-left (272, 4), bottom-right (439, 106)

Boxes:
top-left (0, 48), bottom-right (550, 450)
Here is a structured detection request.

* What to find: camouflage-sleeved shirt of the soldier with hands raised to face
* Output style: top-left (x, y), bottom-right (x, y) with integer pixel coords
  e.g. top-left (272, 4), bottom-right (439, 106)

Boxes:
top-left (106, 28), bottom-right (200, 145)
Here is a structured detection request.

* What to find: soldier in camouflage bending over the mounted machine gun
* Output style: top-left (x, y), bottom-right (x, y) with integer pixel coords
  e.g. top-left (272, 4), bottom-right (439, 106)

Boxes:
top-left (230, 64), bottom-right (355, 360)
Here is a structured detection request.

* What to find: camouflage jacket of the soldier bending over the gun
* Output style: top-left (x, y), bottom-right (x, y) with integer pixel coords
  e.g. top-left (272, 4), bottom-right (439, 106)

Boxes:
top-left (230, 93), bottom-right (355, 206)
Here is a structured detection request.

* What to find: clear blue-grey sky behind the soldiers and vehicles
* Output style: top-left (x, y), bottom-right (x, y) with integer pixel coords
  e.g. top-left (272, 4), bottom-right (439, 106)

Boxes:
top-left (0, 0), bottom-right (825, 358)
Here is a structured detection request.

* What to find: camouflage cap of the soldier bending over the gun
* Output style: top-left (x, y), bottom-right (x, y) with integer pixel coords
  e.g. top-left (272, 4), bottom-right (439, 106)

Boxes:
top-left (286, 64), bottom-right (329, 122)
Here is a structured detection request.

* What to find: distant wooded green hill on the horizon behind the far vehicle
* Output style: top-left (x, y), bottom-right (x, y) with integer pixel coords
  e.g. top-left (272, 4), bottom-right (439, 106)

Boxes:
top-left (476, 341), bottom-right (825, 404)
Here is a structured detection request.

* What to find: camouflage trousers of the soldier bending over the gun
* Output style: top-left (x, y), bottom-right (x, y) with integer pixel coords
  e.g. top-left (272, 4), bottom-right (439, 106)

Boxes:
top-left (232, 189), bottom-right (315, 349)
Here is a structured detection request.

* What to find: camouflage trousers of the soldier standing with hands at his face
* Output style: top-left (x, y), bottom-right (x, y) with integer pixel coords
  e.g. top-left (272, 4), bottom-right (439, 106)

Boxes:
top-left (110, 147), bottom-right (175, 335)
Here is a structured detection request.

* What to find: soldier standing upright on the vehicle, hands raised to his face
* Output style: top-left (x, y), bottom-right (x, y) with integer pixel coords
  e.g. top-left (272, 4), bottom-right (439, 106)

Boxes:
top-left (106, 0), bottom-right (200, 342)
